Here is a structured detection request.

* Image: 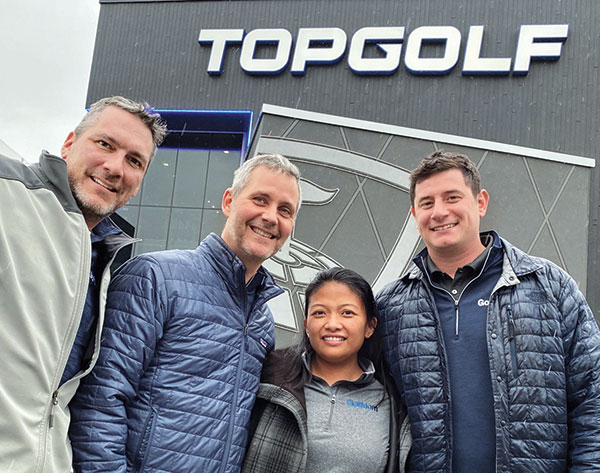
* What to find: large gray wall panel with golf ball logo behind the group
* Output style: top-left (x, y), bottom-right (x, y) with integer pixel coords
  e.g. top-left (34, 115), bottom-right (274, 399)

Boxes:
top-left (250, 105), bottom-right (595, 346)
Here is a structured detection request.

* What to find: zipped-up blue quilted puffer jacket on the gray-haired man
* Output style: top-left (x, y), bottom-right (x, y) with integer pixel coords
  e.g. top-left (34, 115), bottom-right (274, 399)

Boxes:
top-left (70, 234), bottom-right (282, 473)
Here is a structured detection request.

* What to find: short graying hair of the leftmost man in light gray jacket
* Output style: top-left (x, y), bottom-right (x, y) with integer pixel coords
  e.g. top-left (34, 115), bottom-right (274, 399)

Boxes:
top-left (75, 95), bottom-right (167, 158)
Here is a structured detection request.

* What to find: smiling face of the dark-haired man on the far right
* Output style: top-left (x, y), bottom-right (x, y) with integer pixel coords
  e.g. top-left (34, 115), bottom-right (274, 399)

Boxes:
top-left (411, 169), bottom-right (489, 257)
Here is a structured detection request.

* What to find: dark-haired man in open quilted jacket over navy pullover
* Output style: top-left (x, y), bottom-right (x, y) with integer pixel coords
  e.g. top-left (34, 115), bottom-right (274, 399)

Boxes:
top-left (377, 151), bottom-right (600, 473)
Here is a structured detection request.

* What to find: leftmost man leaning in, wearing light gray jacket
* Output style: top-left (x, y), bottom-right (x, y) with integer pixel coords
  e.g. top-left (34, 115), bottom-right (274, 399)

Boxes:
top-left (0, 97), bottom-right (165, 473)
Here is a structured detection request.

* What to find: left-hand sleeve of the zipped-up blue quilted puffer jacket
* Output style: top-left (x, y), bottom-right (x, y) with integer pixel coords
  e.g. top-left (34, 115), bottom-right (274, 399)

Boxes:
top-left (69, 255), bottom-right (166, 473)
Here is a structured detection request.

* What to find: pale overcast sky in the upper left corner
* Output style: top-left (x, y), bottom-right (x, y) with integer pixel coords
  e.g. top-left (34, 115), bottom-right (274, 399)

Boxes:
top-left (0, 0), bottom-right (100, 162)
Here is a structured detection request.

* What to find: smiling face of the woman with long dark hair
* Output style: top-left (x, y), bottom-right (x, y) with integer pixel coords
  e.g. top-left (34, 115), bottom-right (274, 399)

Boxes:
top-left (304, 281), bottom-right (377, 366)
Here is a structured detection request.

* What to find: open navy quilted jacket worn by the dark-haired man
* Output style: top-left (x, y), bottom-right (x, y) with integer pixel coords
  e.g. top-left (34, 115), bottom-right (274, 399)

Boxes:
top-left (377, 234), bottom-right (600, 473)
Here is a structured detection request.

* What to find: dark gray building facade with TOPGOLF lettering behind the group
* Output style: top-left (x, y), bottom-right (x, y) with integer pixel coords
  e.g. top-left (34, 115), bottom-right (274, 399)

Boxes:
top-left (87, 0), bottom-right (600, 344)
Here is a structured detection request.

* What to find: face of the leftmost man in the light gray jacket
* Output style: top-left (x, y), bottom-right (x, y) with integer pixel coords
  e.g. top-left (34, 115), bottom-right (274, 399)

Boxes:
top-left (61, 106), bottom-right (153, 229)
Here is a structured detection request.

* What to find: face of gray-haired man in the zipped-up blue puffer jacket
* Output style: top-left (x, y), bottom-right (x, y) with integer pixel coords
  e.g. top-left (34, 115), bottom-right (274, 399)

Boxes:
top-left (222, 166), bottom-right (299, 274)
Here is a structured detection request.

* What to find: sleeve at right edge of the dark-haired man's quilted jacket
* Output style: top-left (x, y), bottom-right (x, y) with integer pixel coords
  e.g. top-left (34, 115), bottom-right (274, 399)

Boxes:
top-left (558, 275), bottom-right (600, 473)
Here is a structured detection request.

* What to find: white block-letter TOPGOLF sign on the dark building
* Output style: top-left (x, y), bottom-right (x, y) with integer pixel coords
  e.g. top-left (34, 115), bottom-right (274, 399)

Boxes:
top-left (198, 24), bottom-right (569, 76)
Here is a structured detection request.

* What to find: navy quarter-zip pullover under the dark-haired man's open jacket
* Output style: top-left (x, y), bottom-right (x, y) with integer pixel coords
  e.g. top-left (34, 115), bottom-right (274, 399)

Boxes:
top-left (419, 232), bottom-right (502, 473)
